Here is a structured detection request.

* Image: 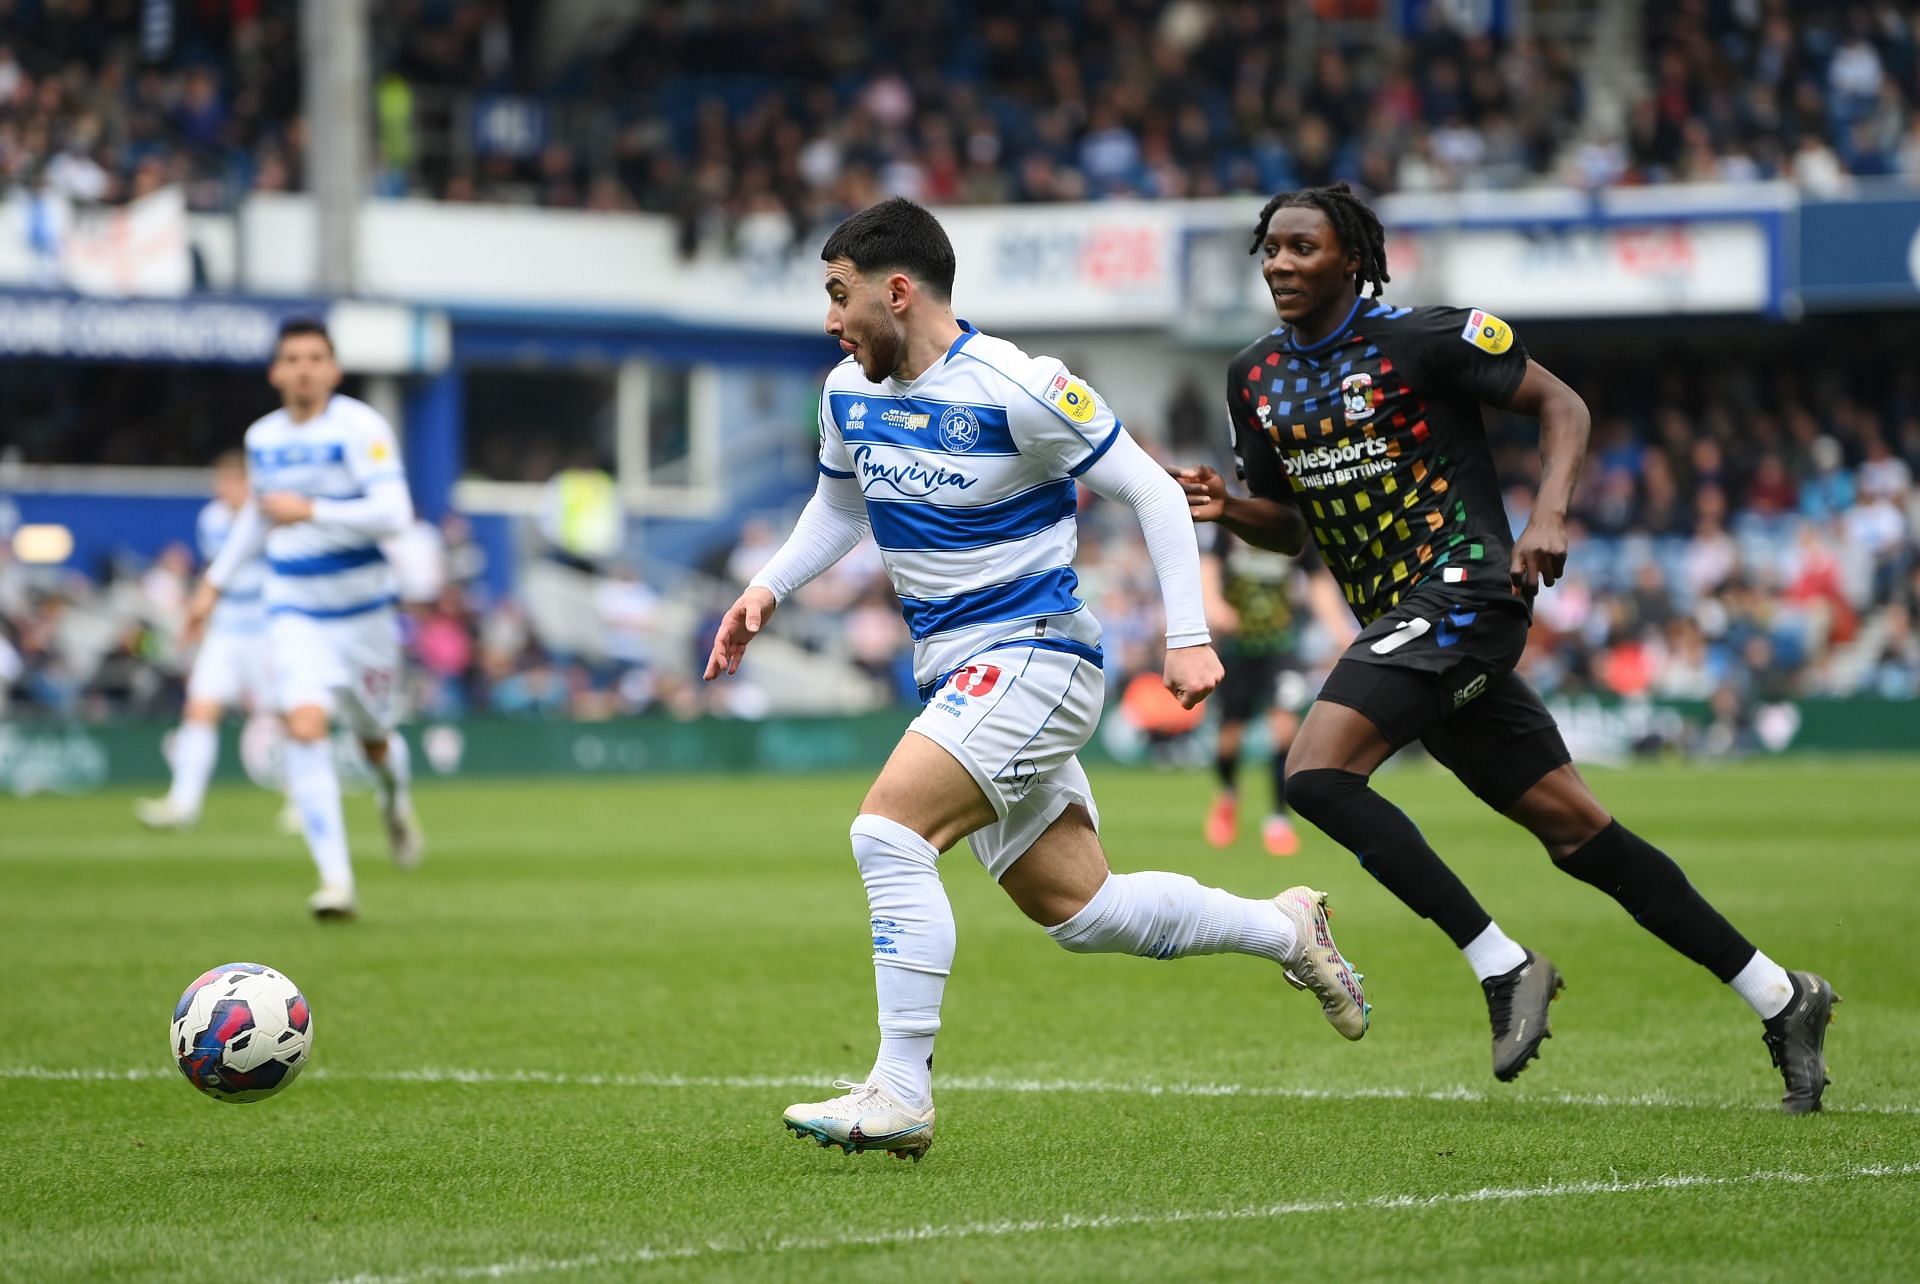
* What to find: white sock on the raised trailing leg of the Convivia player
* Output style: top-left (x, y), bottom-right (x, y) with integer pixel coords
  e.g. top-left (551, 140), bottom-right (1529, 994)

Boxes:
top-left (1046, 871), bottom-right (1298, 963)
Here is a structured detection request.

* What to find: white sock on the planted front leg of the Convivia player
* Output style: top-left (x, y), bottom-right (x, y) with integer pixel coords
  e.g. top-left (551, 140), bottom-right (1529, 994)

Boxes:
top-left (849, 816), bottom-right (954, 1109)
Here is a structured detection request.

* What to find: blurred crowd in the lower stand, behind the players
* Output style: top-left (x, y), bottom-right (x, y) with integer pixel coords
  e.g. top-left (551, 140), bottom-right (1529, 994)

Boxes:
top-left (0, 351), bottom-right (1920, 744)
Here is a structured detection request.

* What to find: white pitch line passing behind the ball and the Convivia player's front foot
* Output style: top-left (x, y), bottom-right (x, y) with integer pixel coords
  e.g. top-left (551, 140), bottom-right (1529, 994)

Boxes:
top-left (11, 1065), bottom-right (1920, 1115)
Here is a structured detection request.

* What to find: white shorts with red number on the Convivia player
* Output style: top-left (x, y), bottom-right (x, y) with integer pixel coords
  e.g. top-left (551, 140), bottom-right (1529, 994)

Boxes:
top-left (908, 645), bottom-right (1106, 881)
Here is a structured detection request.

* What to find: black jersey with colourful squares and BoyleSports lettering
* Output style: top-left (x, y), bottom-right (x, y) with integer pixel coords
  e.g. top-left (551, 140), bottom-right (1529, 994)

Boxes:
top-left (1227, 297), bottom-right (1526, 624)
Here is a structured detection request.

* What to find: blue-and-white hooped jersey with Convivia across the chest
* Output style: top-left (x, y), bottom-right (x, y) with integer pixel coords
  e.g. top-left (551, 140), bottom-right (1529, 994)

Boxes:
top-left (820, 321), bottom-right (1123, 697)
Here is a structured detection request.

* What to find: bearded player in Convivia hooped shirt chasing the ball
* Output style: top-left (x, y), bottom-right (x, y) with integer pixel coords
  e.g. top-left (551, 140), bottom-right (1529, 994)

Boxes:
top-left (707, 200), bottom-right (1367, 1159)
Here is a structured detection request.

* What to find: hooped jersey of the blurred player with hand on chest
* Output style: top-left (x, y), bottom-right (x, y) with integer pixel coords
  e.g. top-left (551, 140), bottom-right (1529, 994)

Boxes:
top-left (246, 393), bottom-right (405, 620)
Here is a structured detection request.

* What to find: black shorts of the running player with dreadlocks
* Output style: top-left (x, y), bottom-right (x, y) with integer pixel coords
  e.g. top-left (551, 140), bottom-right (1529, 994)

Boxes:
top-left (1319, 583), bottom-right (1572, 812)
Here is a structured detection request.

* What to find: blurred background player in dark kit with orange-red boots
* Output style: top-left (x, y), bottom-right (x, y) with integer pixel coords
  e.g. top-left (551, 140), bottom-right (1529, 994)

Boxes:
top-left (1200, 524), bottom-right (1354, 856)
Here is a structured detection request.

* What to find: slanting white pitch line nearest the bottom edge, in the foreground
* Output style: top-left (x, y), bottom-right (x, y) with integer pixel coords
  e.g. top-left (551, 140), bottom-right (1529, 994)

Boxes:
top-left (332, 1163), bottom-right (1920, 1284)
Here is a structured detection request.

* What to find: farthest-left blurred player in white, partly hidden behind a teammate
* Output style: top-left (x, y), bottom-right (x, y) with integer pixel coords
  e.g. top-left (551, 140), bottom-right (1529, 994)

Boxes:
top-left (134, 451), bottom-right (291, 829)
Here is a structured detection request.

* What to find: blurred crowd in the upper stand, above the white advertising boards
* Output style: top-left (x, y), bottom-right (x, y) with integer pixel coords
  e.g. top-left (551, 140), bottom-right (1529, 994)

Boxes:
top-left (0, 0), bottom-right (1920, 226)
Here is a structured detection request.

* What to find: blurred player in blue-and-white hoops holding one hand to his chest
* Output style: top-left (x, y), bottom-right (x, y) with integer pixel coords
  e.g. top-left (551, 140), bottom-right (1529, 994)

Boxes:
top-left (188, 321), bottom-right (420, 917)
